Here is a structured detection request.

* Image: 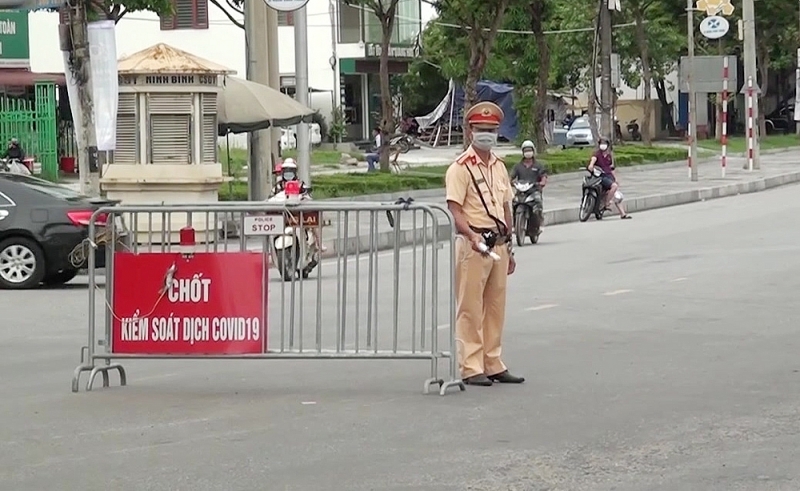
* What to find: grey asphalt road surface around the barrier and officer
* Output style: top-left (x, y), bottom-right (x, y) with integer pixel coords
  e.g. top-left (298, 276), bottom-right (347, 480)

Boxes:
top-left (0, 186), bottom-right (800, 491)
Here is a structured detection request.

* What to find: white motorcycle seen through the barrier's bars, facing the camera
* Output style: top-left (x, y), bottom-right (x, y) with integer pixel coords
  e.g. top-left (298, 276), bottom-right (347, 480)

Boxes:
top-left (267, 188), bottom-right (320, 281)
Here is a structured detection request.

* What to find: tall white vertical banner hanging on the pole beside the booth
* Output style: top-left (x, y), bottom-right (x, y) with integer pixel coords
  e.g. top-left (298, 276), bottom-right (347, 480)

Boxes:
top-left (62, 20), bottom-right (119, 151)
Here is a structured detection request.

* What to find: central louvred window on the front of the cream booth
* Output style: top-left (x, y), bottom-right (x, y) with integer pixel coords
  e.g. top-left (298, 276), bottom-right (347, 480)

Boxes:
top-left (147, 94), bottom-right (193, 165)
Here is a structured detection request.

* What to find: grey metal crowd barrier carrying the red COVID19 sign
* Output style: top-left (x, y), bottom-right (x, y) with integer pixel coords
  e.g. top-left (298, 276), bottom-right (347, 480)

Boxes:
top-left (72, 201), bottom-right (465, 395)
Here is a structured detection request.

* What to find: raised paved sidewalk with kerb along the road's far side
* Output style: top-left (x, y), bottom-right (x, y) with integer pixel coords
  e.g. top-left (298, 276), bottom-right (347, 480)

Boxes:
top-left (316, 149), bottom-right (800, 255)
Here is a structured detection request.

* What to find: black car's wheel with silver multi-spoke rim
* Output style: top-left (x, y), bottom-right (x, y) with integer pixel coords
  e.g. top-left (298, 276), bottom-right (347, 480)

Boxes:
top-left (0, 237), bottom-right (45, 290)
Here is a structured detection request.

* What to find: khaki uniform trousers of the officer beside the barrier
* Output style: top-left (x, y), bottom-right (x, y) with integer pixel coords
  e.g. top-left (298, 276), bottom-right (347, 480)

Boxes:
top-left (455, 236), bottom-right (508, 378)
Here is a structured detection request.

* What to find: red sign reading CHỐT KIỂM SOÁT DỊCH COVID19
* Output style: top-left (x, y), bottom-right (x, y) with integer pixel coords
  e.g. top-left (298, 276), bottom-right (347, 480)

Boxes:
top-left (111, 252), bottom-right (267, 355)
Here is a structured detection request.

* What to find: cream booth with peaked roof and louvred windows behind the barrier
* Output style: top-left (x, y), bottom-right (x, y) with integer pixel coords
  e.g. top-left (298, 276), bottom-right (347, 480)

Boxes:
top-left (100, 44), bottom-right (228, 243)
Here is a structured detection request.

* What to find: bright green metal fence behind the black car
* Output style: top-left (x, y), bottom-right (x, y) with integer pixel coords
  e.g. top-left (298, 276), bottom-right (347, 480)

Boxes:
top-left (0, 83), bottom-right (58, 181)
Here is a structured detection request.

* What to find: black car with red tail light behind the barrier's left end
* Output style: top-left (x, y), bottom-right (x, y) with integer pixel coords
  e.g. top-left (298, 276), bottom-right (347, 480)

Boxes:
top-left (0, 173), bottom-right (121, 289)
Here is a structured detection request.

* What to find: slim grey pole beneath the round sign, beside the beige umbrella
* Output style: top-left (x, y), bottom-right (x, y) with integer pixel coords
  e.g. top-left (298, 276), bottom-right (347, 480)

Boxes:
top-left (294, 6), bottom-right (311, 184)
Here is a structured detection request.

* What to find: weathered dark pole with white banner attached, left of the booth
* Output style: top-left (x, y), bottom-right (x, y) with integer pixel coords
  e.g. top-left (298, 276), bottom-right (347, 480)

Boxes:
top-left (68, 0), bottom-right (100, 196)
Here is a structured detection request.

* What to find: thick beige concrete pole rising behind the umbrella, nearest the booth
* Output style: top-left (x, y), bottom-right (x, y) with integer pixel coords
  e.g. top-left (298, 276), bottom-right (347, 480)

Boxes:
top-left (244, 0), bottom-right (272, 201)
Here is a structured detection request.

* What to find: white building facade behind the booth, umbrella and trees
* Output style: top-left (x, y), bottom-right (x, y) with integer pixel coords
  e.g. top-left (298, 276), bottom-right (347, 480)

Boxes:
top-left (30, 0), bottom-right (434, 139)
